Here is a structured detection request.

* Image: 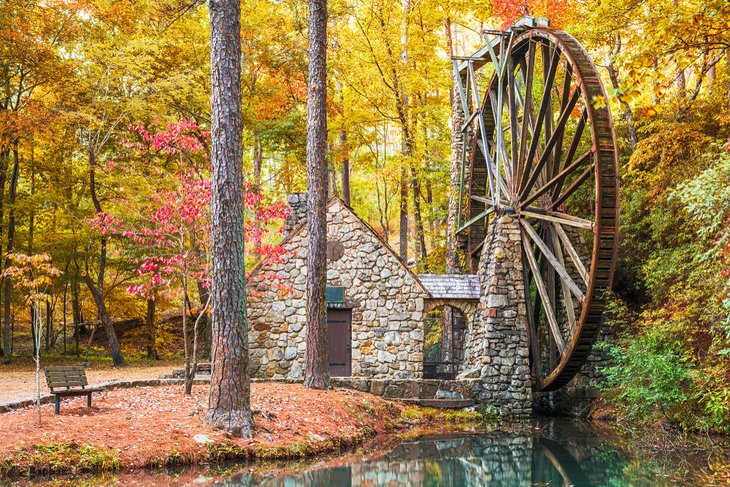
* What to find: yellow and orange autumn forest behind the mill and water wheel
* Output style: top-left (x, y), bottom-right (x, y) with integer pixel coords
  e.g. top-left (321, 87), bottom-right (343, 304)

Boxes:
top-left (0, 0), bottom-right (730, 432)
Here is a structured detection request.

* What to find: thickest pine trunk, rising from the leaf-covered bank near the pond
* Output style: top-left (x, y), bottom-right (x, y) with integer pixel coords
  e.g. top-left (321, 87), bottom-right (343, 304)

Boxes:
top-left (205, 0), bottom-right (254, 437)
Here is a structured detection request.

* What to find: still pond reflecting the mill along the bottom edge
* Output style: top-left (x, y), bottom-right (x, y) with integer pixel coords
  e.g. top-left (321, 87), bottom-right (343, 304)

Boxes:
top-left (9, 419), bottom-right (730, 487)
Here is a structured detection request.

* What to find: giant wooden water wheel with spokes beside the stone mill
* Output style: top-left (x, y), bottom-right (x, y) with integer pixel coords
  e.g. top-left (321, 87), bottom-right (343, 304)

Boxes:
top-left (454, 18), bottom-right (618, 391)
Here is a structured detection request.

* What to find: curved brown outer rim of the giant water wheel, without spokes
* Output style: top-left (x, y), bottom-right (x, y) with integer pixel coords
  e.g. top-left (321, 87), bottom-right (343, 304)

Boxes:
top-left (469, 28), bottom-right (619, 391)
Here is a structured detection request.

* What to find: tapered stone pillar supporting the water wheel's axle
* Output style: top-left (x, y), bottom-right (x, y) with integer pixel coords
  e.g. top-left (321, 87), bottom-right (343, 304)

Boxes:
top-left (459, 215), bottom-right (532, 416)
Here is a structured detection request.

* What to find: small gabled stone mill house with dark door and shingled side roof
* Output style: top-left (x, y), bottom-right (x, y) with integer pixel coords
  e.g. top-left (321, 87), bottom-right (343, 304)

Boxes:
top-left (248, 193), bottom-right (479, 380)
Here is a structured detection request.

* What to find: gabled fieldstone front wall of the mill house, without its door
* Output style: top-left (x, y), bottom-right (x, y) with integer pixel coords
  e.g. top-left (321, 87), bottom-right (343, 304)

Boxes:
top-left (248, 198), bottom-right (429, 380)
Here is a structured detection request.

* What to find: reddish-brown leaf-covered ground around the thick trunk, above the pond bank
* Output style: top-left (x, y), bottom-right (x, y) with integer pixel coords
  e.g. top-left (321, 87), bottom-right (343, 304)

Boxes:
top-left (0, 383), bottom-right (399, 468)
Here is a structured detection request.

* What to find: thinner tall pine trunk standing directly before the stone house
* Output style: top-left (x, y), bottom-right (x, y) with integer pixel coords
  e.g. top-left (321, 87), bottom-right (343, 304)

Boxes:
top-left (304, 0), bottom-right (330, 389)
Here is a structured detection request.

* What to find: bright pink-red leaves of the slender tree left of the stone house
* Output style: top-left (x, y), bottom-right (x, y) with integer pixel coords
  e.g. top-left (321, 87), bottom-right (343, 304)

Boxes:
top-left (115, 119), bottom-right (288, 299)
